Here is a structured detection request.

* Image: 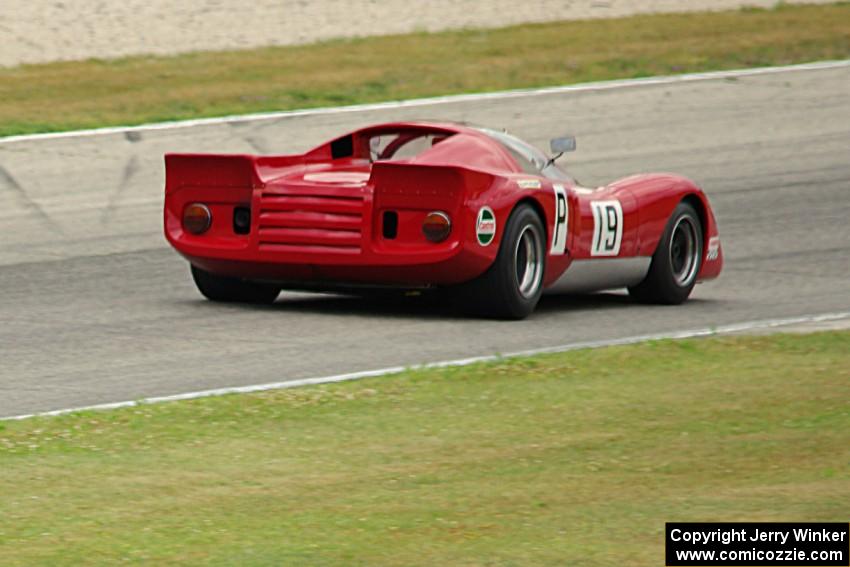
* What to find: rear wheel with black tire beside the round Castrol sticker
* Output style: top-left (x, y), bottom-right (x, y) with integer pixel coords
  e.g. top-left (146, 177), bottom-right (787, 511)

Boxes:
top-left (456, 204), bottom-right (546, 320)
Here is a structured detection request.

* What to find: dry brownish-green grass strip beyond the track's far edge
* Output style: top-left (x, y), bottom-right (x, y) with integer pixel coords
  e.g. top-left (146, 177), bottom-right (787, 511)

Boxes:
top-left (0, 2), bottom-right (850, 136)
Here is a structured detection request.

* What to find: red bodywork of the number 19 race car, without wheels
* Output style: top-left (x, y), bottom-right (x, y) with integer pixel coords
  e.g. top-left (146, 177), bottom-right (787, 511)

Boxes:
top-left (164, 123), bottom-right (722, 287)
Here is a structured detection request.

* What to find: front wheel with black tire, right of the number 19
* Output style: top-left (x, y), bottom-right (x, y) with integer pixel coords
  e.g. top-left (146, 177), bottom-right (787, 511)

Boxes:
top-left (629, 202), bottom-right (704, 305)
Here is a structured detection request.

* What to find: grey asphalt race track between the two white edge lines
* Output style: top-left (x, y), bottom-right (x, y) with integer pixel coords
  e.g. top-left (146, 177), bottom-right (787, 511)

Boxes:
top-left (0, 66), bottom-right (850, 416)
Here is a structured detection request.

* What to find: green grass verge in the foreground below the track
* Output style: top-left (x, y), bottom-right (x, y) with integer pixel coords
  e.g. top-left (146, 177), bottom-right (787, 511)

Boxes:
top-left (0, 332), bottom-right (850, 566)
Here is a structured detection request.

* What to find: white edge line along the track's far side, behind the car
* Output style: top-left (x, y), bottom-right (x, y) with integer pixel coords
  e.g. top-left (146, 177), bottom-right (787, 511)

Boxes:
top-left (0, 59), bottom-right (850, 144)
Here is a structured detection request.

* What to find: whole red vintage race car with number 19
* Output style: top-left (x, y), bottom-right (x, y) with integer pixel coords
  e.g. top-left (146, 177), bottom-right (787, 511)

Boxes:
top-left (165, 122), bottom-right (723, 319)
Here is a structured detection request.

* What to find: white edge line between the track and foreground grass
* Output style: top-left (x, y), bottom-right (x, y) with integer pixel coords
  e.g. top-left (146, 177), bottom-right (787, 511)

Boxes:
top-left (0, 311), bottom-right (850, 421)
